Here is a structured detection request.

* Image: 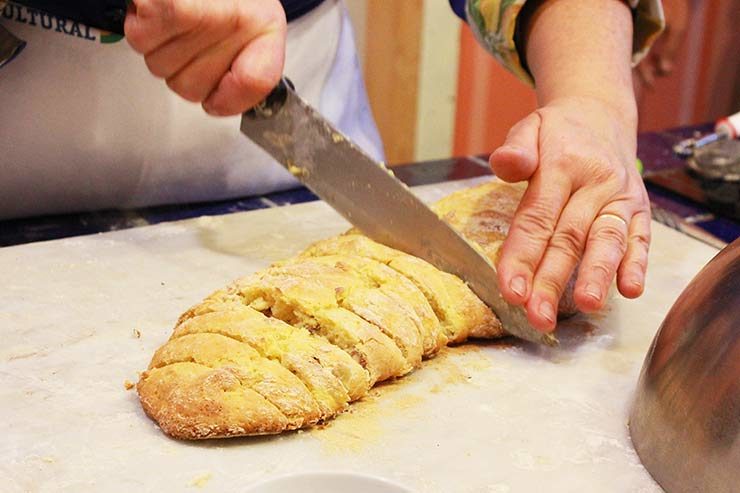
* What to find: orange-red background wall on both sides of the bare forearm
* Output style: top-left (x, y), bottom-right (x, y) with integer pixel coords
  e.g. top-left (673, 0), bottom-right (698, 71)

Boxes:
top-left (454, 0), bottom-right (740, 155)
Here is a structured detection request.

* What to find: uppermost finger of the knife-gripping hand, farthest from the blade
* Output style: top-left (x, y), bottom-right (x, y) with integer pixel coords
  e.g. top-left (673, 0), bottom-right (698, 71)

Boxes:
top-left (123, 0), bottom-right (202, 55)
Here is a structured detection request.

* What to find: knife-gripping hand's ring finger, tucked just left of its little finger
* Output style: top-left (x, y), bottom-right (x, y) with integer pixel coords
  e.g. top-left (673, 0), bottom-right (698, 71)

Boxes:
top-left (167, 31), bottom-right (244, 103)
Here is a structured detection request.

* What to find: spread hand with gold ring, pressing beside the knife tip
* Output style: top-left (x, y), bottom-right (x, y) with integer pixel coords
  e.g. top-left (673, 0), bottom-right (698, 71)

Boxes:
top-left (490, 97), bottom-right (650, 331)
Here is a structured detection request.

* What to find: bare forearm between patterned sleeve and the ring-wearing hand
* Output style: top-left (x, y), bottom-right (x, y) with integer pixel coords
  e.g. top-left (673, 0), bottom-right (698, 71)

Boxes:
top-left (521, 0), bottom-right (637, 125)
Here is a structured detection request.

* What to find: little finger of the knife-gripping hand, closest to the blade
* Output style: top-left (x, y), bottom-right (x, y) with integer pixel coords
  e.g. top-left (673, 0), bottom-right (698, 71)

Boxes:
top-left (203, 25), bottom-right (285, 116)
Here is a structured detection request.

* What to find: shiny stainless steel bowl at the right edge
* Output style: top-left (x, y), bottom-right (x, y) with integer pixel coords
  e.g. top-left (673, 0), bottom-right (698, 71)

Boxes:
top-left (630, 239), bottom-right (740, 493)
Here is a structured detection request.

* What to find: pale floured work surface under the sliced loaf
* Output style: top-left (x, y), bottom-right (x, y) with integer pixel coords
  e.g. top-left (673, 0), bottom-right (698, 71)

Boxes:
top-left (0, 178), bottom-right (716, 492)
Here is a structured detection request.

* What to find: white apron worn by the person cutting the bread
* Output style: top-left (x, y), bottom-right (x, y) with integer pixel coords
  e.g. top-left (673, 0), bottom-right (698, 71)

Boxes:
top-left (0, 0), bottom-right (382, 219)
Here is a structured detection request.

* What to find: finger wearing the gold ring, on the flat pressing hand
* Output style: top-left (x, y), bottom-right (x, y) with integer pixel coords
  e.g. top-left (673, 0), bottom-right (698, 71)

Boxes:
top-left (574, 206), bottom-right (631, 312)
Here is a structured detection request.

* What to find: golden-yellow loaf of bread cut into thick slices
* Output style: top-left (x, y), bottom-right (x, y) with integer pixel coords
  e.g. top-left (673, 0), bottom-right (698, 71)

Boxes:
top-left (136, 181), bottom-right (573, 440)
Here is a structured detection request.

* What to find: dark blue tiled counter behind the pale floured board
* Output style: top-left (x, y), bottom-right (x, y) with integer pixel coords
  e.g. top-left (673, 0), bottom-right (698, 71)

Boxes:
top-left (0, 125), bottom-right (740, 246)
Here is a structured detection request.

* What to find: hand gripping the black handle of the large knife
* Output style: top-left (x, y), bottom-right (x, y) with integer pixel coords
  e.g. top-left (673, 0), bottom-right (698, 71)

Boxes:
top-left (124, 0), bottom-right (286, 115)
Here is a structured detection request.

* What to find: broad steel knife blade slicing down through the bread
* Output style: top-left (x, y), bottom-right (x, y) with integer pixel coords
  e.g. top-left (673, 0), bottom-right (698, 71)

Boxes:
top-left (241, 79), bottom-right (558, 346)
